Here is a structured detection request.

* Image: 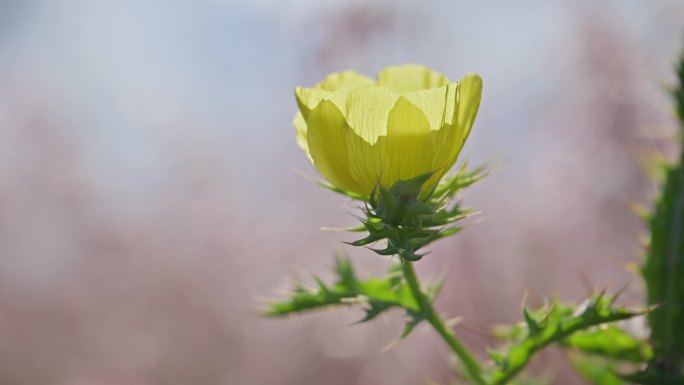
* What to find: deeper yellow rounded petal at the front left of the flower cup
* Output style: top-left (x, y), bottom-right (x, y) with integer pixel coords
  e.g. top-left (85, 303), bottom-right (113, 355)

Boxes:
top-left (307, 100), bottom-right (366, 194)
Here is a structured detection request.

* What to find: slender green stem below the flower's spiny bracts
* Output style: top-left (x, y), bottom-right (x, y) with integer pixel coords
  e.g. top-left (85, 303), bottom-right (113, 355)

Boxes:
top-left (402, 261), bottom-right (485, 385)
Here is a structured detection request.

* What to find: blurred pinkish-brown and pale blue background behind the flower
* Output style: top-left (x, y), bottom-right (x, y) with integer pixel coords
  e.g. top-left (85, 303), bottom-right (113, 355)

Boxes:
top-left (0, 0), bottom-right (684, 385)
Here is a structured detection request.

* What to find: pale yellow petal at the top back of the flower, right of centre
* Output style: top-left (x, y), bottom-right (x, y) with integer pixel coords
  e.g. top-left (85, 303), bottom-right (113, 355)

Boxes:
top-left (378, 64), bottom-right (449, 92)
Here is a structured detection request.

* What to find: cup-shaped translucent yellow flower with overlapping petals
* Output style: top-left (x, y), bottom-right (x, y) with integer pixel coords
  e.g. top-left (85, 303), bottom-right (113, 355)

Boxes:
top-left (294, 64), bottom-right (482, 198)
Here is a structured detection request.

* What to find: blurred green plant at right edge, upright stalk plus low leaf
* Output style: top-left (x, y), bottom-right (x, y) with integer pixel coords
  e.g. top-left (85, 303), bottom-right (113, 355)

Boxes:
top-left (568, 51), bottom-right (684, 385)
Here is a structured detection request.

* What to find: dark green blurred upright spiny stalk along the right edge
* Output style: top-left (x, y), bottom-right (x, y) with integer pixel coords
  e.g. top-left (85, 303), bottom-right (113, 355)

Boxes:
top-left (642, 52), bottom-right (684, 370)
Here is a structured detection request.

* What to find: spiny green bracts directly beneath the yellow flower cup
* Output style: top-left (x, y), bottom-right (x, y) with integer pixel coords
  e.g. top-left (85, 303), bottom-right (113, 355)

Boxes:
top-left (350, 165), bottom-right (486, 261)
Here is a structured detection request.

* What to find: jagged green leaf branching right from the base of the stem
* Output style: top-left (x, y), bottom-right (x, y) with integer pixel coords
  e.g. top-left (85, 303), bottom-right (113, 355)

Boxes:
top-left (488, 294), bottom-right (644, 385)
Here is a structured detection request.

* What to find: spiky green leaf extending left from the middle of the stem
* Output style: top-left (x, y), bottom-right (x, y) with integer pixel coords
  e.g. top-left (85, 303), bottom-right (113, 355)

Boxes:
top-left (263, 258), bottom-right (442, 338)
